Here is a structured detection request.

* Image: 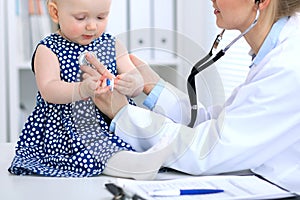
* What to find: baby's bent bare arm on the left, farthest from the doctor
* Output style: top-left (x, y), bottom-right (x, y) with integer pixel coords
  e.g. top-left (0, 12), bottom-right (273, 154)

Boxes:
top-left (34, 45), bottom-right (97, 104)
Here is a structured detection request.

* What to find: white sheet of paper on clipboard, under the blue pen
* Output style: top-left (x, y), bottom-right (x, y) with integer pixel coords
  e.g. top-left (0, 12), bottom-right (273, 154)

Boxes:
top-left (117, 176), bottom-right (292, 200)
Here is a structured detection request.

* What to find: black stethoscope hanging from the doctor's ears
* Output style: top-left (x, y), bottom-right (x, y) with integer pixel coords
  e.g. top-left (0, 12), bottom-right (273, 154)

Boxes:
top-left (187, 0), bottom-right (260, 127)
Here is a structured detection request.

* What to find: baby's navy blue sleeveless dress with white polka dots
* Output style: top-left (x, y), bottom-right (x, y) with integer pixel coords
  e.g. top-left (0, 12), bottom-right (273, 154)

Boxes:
top-left (8, 33), bottom-right (134, 177)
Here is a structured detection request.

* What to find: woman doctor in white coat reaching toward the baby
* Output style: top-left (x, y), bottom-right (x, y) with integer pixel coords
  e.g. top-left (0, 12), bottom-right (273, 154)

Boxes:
top-left (83, 0), bottom-right (300, 192)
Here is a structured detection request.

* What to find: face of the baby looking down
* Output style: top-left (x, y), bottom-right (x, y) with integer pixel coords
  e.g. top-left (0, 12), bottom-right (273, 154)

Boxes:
top-left (55, 0), bottom-right (111, 45)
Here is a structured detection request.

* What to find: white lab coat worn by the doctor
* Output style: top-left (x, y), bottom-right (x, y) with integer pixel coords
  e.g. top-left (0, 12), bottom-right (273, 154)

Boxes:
top-left (113, 17), bottom-right (300, 192)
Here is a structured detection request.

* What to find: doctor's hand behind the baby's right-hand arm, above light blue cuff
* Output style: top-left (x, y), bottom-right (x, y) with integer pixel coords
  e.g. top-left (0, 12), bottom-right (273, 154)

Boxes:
top-left (129, 54), bottom-right (161, 95)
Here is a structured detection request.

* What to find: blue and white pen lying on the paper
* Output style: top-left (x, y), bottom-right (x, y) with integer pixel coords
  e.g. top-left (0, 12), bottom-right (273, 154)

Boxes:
top-left (148, 189), bottom-right (224, 196)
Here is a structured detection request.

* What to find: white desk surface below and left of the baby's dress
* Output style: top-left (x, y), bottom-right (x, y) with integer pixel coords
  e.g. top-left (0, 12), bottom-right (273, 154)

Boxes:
top-left (0, 143), bottom-right (122, 200)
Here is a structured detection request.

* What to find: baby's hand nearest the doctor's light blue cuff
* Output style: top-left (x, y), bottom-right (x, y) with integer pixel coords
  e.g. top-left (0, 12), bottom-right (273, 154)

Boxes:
top-left (114, 69), bottom-right (144, 97)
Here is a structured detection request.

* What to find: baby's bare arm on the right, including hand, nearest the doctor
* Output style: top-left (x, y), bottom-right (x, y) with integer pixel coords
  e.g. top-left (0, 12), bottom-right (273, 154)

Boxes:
top-left (115, 40), bottom-right (144, 97)
